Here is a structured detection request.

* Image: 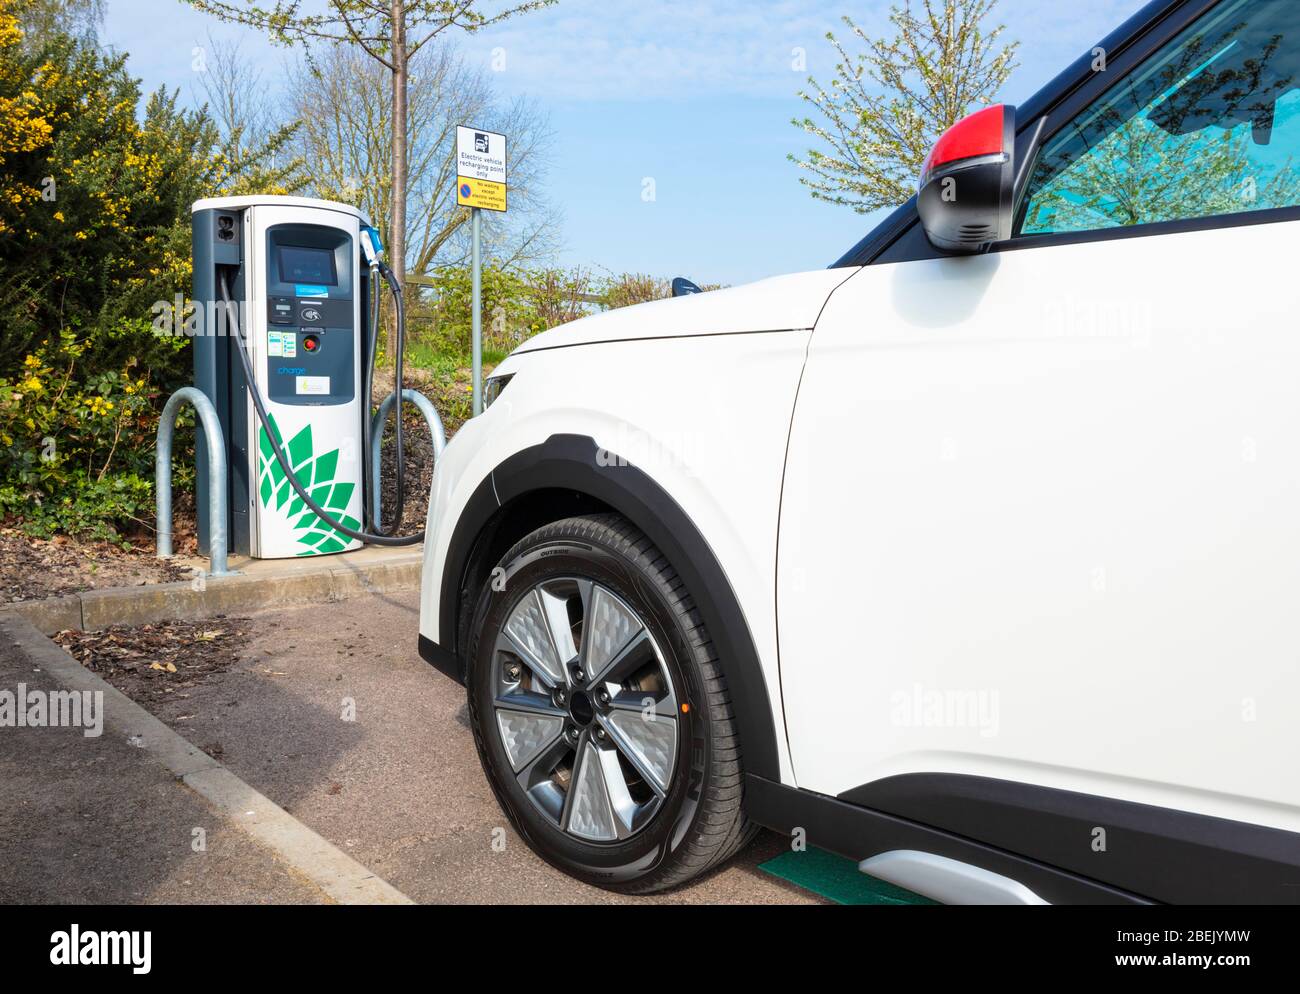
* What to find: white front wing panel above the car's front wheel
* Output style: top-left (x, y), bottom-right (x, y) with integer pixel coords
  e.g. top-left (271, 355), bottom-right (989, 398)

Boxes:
top-left (420, 326), bottom-right (816, 778)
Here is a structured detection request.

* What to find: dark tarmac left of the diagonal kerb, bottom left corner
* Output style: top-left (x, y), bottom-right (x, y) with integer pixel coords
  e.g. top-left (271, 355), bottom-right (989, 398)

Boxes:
top-left (0, 643), bottom-right (326, 904)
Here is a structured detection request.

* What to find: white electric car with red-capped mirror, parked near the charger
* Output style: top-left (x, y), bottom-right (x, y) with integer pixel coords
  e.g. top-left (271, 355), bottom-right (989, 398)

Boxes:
top-left (420, 0), bottom-right (1300, 903)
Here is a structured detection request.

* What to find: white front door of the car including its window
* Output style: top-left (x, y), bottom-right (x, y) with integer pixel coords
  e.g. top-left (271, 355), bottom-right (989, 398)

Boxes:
top-left (777, 0), bottom-right (1300, 847)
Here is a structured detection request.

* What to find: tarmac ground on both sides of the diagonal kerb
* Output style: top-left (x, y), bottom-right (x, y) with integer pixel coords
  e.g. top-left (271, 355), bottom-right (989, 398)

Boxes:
top-left (0, 591), bottom-right (823, 904)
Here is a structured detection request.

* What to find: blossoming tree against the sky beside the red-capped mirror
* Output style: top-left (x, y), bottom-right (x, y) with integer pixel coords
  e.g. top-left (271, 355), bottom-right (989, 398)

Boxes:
top-left (789, 0), bottom-right (1018, 214)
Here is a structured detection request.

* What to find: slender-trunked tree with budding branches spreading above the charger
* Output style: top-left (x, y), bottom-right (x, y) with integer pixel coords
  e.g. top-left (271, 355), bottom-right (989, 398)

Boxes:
top-left (185, 0), bottom-right (555, 352)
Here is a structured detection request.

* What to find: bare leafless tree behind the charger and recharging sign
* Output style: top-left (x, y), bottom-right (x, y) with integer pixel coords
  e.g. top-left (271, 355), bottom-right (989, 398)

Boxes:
top-left (290, 44), bottom-right (554, 275)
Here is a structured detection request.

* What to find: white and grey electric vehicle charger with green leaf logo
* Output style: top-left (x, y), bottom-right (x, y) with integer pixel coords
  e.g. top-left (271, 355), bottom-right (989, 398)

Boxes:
top-left (192, 196), bottom-right (423, 559)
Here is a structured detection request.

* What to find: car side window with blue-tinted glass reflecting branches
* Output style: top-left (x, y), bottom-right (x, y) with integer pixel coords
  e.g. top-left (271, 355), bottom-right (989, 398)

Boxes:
top-left (1017, 0), bottom-right (1300, 235)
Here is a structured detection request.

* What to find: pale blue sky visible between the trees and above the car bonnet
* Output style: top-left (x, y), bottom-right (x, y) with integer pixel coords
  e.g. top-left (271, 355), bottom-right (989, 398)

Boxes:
top-left (104, 0), bottom-right (1143, 283)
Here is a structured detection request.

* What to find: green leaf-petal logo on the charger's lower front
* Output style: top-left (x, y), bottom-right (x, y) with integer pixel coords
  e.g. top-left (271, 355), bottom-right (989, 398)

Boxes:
top-left (257, 414), bottom-right (361, 556)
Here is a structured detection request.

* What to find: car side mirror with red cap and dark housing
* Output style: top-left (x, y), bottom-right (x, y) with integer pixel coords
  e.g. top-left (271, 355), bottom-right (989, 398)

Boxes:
top-left (917, 104), bottom-right (1015, 255)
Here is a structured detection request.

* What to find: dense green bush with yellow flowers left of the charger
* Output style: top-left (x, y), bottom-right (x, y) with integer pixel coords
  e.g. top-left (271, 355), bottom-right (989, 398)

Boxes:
top-left (0, 0), bottom-right (298, 541)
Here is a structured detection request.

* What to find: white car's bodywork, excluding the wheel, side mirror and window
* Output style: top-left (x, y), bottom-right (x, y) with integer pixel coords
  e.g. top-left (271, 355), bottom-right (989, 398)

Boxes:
top-left (421, 0), bottom-right (1300, 903)
